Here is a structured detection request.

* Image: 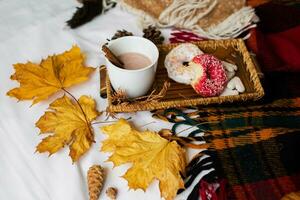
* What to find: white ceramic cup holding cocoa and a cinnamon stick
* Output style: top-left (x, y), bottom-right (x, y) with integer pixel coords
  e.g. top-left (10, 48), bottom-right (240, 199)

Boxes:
top-left (105, 36), bottom-right (159, 98)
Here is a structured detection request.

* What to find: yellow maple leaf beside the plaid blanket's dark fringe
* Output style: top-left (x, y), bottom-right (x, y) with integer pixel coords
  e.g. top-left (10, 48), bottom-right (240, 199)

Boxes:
top-left (101, 119), bottom-right (186, 200)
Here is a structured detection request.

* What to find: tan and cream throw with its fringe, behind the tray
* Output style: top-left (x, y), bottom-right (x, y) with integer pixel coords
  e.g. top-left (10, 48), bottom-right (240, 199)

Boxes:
top-left (120, 0), bottom-right (258, 39)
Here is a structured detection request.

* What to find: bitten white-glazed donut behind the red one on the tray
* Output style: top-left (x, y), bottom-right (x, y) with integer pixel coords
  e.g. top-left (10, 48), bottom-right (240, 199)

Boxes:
top-left (165, 43), bottom-right (203, 85)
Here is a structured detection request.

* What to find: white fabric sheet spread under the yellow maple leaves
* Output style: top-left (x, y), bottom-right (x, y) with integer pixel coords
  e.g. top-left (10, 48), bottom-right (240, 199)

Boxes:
top-left (0, 0), bottom-right (206, 200)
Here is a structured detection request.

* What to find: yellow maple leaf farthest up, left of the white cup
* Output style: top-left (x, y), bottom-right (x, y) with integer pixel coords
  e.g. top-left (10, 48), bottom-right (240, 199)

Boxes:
top-left (7, 46), bottom-right (95, 104)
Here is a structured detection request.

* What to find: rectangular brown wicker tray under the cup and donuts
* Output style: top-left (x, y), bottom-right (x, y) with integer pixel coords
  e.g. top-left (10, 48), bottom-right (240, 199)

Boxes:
top-left (106, 39), bottom-right (264, 113)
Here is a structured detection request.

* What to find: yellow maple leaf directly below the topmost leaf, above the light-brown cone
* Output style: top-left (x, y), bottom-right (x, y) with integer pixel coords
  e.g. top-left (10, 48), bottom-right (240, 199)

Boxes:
top-left (36, 96), bottom-right (99, 162)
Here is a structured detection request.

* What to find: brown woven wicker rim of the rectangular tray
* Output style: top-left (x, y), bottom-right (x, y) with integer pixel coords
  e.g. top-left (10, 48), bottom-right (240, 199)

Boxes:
top-left (106, 39), bottom-right (264, 113)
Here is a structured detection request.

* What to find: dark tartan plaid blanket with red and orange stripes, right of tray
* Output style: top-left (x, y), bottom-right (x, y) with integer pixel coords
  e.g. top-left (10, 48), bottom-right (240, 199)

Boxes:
top-left (165, 0), bottom-right (300, 200)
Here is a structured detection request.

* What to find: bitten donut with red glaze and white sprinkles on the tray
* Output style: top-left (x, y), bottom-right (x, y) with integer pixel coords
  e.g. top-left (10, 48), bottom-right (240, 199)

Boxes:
top-left (189, 54), bottom-right (227, 97)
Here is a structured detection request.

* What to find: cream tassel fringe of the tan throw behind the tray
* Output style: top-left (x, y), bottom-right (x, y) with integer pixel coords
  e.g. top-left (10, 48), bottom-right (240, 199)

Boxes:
top-left (120, 0), bottom-right (258, 39)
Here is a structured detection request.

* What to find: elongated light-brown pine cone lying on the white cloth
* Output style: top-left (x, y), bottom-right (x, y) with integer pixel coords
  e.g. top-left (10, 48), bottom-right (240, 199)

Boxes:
top-left (87, 165), bottom-right (104, 200)
